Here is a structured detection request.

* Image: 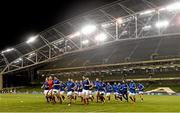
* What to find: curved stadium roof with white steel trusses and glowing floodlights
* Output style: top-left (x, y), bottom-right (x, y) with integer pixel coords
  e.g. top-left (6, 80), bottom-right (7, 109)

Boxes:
top-left (0, 0), bottom-right (180, 73)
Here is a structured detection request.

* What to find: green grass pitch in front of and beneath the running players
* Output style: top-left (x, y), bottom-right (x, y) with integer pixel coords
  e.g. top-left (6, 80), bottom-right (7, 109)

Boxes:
top-left (0, 94), bottom-right (180, 112)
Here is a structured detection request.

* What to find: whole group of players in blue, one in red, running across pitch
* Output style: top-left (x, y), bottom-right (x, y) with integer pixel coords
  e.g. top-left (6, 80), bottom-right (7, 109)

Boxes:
top-left (42, 76), bottom-right (144, 105)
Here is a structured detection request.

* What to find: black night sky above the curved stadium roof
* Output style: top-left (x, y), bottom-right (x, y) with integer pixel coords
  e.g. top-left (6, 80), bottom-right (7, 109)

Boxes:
top-left (0, 0), bottom-right (116, 50)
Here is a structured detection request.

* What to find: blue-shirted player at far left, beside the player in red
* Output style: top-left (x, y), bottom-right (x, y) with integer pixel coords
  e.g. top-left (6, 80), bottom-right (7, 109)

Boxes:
top-left (41, 77), bottom-right (50, 102)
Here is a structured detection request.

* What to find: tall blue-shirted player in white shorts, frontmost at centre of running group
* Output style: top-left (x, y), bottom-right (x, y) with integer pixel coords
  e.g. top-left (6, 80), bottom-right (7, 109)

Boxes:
top-left (82, 76), bottom-right (90, 105)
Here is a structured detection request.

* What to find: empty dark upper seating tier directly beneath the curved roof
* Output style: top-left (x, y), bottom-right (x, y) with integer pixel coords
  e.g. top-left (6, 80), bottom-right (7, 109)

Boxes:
top-left (43, 35), bottom-right (180, 69)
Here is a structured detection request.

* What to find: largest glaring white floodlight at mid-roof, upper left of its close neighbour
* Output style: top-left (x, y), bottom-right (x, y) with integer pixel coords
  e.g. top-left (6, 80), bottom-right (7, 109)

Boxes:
top-left (81, 25), bottom-right (96, 35)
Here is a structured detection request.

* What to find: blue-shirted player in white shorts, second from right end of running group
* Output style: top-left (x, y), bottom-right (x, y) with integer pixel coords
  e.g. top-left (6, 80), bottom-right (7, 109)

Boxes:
top-left (129, 80), bottom-right (136, 102)
